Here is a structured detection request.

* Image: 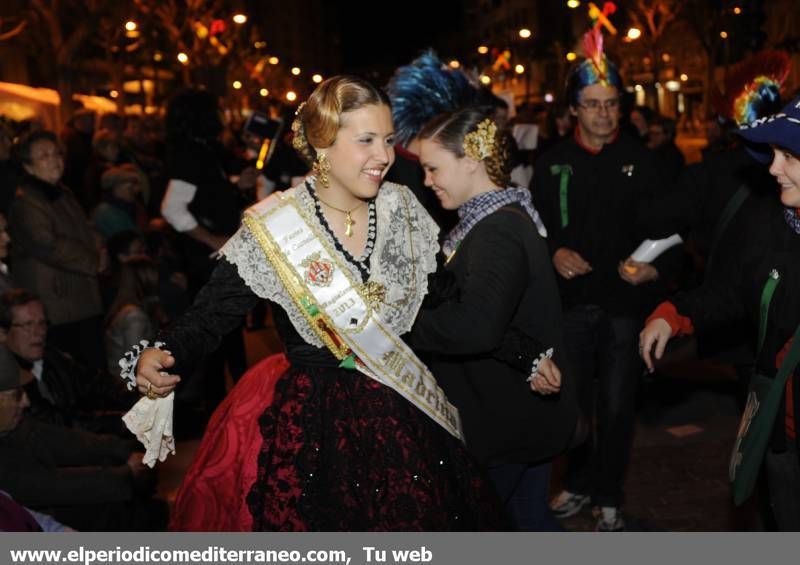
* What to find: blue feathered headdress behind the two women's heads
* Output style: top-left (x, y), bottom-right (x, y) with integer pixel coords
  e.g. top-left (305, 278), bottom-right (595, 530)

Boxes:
top-left (386, 50), bottom-right (479, 146)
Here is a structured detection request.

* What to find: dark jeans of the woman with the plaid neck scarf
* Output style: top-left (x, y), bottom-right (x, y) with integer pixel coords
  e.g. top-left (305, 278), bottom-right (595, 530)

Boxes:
top-left (489, 462), bottom-right (564, 532)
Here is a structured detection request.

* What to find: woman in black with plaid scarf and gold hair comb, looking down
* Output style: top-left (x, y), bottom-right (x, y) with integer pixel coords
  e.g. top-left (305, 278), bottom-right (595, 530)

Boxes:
top-left (410, 108), bottom-right (578, 531)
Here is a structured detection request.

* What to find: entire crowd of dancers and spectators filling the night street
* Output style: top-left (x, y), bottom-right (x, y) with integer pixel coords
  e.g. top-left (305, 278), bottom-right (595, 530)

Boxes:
top-left (0, 30), bottom-right (800, 531)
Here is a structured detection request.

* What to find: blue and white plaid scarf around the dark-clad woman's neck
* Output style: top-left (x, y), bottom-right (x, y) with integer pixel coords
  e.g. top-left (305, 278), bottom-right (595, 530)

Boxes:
top-left (442, 186), bottom-right (547, 257)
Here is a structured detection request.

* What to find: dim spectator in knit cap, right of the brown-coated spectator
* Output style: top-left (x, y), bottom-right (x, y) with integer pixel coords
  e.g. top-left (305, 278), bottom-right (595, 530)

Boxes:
top-left (92, 164), bottom-right (147, 240)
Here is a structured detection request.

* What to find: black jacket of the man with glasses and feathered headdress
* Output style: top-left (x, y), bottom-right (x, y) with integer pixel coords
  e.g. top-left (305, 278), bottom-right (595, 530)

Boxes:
top-left (531, 133), bottom-right (681, 316)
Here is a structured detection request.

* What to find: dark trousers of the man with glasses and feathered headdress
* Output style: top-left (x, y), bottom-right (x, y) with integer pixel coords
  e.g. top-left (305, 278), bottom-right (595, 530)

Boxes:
top-left (564, 305), bottom-right (643, 507)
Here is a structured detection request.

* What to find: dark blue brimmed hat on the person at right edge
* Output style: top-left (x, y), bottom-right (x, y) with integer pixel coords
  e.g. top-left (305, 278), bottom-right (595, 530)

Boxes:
top-left (736, 96), bottom-right (800, 163)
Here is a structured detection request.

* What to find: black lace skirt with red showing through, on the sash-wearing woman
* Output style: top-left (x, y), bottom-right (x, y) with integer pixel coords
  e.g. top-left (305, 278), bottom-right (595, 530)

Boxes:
top-left (247, 367), bottom-right (505, 531)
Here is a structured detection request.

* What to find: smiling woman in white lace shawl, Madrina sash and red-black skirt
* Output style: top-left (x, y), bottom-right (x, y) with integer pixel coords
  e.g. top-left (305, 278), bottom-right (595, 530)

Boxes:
top-left (130, 76), bottom-right (506, 531)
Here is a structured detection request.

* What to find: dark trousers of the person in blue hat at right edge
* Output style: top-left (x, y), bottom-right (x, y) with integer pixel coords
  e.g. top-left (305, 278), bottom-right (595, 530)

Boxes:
top-left (766, 440), bottom-right (800, 532)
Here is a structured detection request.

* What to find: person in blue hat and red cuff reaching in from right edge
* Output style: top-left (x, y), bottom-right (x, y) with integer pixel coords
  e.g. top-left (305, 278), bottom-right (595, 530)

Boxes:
top-left (640, 92), bottom-right (800, 531)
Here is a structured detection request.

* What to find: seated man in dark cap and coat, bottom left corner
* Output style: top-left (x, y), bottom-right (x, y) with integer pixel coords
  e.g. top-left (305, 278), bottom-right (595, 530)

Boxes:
top-left (0, 347), bottom-right (166, 531)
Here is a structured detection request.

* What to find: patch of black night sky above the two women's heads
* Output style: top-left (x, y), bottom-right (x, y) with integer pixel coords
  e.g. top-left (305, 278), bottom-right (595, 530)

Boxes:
top-left (338, 0), bottom-right (463, 72)
